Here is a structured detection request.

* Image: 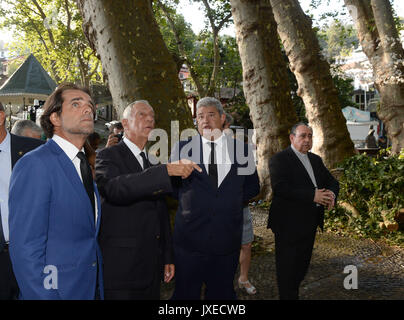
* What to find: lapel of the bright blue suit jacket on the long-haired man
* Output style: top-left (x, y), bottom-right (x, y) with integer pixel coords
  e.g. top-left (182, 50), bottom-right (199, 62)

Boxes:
top-left (47, 139), bottom-right (96, 227)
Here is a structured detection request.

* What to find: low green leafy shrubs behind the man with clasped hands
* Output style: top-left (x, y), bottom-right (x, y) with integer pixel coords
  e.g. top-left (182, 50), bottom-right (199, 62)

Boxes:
top-left (325, 150), bottom-right (404, 245)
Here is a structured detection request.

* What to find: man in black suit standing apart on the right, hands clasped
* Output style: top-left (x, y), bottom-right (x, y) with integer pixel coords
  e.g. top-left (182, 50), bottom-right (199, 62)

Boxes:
top-left (268, 123), bottom-right (339, 300)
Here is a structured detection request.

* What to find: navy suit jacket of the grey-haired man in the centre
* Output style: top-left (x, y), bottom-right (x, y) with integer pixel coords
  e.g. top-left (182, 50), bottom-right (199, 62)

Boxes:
top-left (171, 136), bottom-right (260, 255)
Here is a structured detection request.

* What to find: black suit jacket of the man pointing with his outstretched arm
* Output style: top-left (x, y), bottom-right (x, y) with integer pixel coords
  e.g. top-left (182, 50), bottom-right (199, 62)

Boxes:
top-left (95, 141), bottom-right (173, 290)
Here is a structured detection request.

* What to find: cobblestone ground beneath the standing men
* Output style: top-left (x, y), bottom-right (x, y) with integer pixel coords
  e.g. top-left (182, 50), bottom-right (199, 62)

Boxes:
top-left (161, 210), bottom-right (404, 300)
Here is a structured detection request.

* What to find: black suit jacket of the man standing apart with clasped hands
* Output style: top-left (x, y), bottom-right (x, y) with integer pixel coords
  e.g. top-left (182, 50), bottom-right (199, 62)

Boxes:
top-left (268, 146), bottom-right (339, 238)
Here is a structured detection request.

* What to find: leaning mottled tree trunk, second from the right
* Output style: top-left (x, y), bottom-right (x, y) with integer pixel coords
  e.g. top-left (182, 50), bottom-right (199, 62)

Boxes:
top-left (270, 0), bottom-right (354, 167)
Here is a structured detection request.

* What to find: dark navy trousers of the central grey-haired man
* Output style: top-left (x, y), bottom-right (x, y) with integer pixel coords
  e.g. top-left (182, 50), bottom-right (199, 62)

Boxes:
top-left (171, 247), bottom-right (240, 300)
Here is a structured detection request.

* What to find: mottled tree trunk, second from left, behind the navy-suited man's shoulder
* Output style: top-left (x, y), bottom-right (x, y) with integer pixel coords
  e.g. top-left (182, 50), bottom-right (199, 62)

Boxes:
top-left (230, 0), bottom-right (298, 199)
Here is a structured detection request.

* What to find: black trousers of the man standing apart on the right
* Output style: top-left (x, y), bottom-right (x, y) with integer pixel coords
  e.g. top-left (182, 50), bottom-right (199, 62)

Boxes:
top-left (275, 230), bottom-right (316, 300)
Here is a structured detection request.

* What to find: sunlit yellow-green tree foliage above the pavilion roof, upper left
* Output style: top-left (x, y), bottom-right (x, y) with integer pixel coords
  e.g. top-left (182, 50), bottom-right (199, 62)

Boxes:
top-left (0, 0), bottom-right (101, 86)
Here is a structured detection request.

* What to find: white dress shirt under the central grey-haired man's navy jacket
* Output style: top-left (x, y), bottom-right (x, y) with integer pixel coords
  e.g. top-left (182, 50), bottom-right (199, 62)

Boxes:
top-left (202, 133), bottom-right (232, 187)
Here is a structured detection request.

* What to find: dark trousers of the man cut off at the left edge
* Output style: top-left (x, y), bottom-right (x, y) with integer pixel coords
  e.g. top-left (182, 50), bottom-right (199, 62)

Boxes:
top-left (0, 248), bottom-right (19, 300)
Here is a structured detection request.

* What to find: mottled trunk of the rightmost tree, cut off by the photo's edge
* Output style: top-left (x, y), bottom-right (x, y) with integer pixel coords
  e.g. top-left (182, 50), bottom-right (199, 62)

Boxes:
top-left (345, 0), bottom-right (404, 154)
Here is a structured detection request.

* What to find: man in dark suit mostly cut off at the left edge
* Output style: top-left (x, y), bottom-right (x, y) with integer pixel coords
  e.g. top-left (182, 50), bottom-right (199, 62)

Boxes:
top-left (0, 103), bottom-right (44, 300)
